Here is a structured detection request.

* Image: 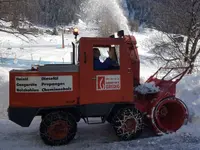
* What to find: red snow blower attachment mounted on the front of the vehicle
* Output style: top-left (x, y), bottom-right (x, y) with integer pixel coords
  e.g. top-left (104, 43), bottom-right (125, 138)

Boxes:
top-left (135, 67), bottom-right (189, 134)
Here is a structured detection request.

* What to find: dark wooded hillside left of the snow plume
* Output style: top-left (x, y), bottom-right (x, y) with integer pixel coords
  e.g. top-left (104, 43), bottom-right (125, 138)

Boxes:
top-left (0, 0), bottom-right (80, 29)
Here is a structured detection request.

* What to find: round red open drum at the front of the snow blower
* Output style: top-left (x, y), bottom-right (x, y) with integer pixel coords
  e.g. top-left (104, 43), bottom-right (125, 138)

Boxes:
top-left (151, 97), bottom-right (189, 135)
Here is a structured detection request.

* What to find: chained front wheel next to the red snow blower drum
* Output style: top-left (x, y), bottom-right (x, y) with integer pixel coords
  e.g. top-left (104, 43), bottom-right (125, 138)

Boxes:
top-left (113, 107), bottom-right (143, 141)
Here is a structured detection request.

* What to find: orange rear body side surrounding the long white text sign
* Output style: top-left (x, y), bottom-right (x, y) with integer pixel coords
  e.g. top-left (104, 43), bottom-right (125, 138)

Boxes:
top-left (10, 71), bottom-right (79, 107)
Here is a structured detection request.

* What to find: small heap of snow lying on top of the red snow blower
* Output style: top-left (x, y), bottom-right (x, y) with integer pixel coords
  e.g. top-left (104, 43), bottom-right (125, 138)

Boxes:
top-left (135, 82), bottom-right (160, 94)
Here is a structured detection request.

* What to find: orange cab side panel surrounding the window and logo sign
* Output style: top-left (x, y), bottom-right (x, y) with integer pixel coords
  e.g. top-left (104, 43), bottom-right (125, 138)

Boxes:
top-left (80, 38), bottom-right (133, 104)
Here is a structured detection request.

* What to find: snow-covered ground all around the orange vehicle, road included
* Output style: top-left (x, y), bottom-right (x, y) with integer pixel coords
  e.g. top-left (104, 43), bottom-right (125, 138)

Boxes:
top-left (0, 22), bottom-right (200, 150)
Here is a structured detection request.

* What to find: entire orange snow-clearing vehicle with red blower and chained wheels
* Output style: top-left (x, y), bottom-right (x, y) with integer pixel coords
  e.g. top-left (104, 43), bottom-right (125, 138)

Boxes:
top-left (8, 30), bottom-right (188, 146)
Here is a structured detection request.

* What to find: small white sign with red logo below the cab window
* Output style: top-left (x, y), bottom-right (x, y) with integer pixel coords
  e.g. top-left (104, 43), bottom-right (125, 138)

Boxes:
top-left (96, 75), bottom-right (121, 91)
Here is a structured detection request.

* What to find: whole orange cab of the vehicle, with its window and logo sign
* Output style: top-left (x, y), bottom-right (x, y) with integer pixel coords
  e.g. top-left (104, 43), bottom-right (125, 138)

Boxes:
top-left (77, 30), bottom-right (133, 105)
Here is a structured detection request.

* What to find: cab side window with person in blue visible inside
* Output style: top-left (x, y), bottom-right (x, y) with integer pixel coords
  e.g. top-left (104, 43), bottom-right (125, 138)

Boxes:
top-left (93, 45), bottom-right (120, 70)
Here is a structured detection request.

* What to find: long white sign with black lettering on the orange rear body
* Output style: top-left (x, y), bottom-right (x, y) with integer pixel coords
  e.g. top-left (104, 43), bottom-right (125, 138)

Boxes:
top-left (15, 76), bottom-right (73, 93)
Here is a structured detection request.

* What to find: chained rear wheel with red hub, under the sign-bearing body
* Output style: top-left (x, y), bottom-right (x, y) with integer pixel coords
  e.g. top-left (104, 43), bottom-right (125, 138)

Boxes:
top-left (40, 111), bottom-right (77, 146)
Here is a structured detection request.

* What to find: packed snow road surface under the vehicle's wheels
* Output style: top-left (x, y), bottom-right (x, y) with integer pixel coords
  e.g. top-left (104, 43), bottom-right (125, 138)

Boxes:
top-left (0, 118), bottom-right (200, 150)
